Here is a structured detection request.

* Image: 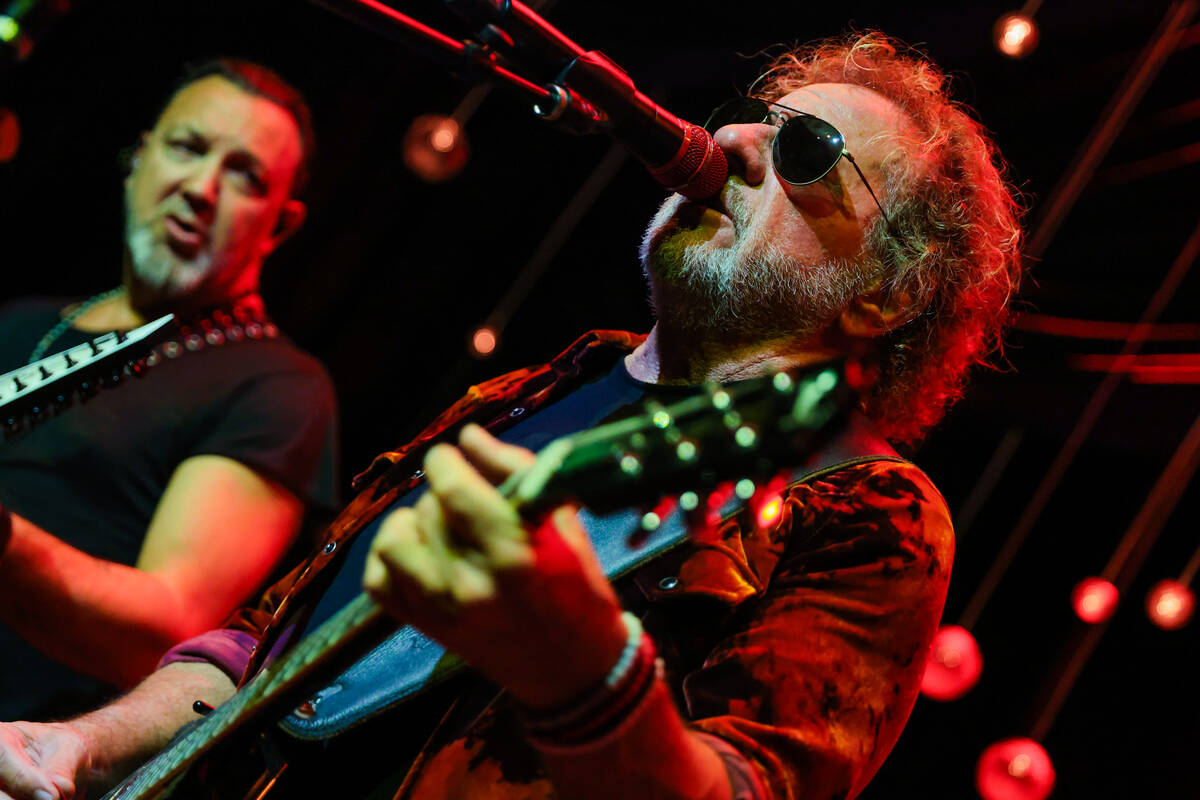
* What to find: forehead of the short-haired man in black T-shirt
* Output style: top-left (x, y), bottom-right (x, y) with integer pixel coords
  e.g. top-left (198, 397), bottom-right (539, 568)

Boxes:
top-left (155, 76), bottom-right (300, 177)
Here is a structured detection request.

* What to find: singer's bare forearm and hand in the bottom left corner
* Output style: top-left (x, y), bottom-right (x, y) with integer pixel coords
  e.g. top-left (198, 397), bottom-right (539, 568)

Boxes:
top-left (0, 663), bottom-right (234, 800)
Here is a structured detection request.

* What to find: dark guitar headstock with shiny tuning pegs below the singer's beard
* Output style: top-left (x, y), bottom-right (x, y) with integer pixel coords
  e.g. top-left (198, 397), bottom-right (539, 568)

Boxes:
top-left (502, 361), bottom-right (857, 513)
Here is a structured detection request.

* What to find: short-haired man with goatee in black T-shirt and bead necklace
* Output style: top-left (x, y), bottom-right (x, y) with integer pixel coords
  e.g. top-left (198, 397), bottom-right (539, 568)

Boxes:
top-left (0, 60), bottom-right (335, 717)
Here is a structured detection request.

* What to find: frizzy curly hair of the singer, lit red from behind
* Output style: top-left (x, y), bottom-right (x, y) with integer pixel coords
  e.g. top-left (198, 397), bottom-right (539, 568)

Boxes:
top-left (755, 31), bottom-right (1021, 443)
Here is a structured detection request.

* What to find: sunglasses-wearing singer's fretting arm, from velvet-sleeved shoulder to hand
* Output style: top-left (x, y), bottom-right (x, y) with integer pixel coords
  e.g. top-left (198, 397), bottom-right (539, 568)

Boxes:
top-left (364, 428), bottom-right (953, 800)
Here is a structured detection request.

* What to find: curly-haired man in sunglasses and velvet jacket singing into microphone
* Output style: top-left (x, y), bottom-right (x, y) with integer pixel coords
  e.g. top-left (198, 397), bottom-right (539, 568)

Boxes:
top-left (0, 35), bottom-right (1020, 799)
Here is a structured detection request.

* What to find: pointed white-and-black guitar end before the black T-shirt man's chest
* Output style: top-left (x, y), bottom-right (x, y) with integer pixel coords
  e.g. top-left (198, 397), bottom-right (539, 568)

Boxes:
top-left (0, 314), bottom-right (176, 437)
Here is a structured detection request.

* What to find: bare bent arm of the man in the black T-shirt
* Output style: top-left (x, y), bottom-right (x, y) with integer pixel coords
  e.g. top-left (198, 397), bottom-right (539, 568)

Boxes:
top-left (0, 456), bottom-right (302, 686)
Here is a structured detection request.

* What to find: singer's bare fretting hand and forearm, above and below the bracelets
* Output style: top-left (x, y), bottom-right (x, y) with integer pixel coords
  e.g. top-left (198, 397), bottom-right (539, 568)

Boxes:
top-left (364, 427), bottom-right (731, 800)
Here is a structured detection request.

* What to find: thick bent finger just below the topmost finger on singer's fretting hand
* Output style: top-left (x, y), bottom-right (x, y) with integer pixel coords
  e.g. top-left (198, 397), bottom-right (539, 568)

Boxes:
top-left (425, 445), bottom-right (527, 557)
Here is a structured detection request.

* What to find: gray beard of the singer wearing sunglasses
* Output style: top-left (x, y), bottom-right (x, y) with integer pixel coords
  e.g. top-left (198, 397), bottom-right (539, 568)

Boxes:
top-left (641, 196), bottom-right (868, 342)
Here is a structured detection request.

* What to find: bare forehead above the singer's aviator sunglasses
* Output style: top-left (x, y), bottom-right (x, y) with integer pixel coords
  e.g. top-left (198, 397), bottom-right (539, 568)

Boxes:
top-left (779, 83), bottom-right (912, 154)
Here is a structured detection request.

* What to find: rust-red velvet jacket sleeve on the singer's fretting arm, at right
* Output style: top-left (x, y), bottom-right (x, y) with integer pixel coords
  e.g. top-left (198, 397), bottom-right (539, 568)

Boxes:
top-left (680, 461), bottom-right (954, 800)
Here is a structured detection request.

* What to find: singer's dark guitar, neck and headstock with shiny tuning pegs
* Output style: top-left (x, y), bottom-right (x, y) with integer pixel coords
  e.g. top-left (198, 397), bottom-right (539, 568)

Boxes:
top-left (103, 366), bottom-right (857, 800)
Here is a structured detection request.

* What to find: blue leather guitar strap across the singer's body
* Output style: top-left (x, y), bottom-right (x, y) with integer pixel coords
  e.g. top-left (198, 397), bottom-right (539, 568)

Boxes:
top-left (280, 413), bottom-right (904, 740)
